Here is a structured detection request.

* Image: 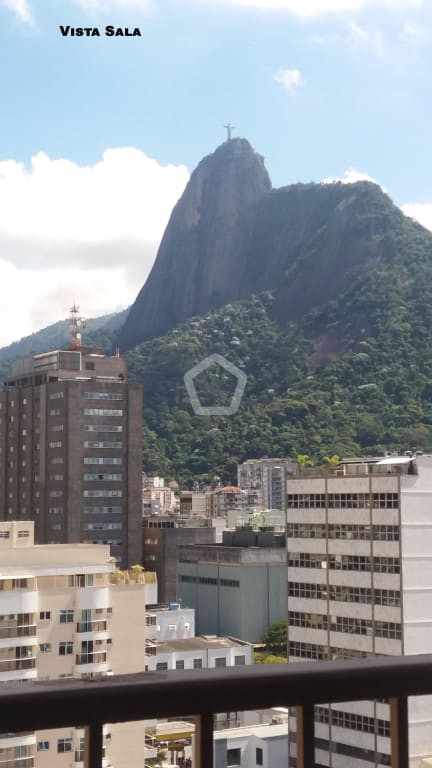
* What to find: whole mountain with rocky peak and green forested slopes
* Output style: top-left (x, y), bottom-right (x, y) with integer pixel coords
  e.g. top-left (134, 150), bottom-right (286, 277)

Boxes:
top-left (3, 139), bottom-right (432, 486)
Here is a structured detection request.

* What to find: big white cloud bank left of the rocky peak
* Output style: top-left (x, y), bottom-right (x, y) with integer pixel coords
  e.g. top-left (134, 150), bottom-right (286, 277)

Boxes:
top-left (0, 147), bottom-right (188, 345)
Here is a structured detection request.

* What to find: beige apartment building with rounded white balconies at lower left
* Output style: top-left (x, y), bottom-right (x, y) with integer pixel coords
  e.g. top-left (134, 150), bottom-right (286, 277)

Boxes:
top-left (0, 521), bottom-right (157, 768)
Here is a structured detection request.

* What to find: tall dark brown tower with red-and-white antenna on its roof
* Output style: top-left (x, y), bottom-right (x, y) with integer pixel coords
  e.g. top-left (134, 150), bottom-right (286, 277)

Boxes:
top-left (0, 347), bottom-right (142, 567)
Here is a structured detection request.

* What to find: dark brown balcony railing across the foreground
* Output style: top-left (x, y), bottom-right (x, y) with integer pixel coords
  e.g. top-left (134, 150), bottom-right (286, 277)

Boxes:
top-left (0, 655), bottom-right (432, 768)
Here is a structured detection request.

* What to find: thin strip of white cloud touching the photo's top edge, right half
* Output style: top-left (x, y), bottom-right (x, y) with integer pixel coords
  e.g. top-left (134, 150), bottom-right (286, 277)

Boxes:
top-left (232, 0), bottom-right (425, 18)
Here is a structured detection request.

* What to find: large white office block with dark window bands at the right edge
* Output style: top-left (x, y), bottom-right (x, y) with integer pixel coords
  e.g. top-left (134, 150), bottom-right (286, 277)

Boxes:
top-left (287, 454), bottom-right (432, 768)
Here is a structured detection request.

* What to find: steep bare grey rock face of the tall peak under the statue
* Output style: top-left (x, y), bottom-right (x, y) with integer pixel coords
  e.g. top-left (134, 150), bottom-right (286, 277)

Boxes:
top-left (119, 138), bottom-right (271, 349)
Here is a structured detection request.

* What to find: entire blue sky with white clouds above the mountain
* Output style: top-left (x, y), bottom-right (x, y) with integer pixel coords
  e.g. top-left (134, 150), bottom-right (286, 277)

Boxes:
top-left (0, 0), bottom-right (432, 346)
